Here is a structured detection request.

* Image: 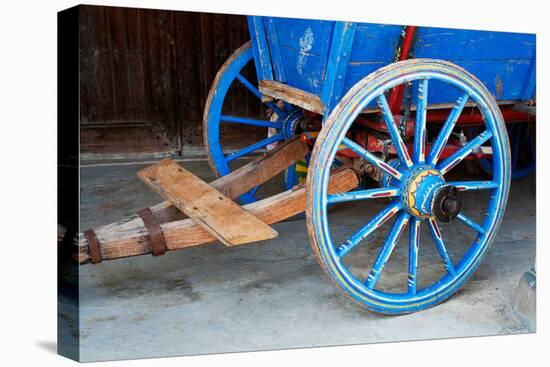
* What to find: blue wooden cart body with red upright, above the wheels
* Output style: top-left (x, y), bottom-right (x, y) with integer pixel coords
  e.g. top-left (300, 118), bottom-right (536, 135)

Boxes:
top-left (248, 16), bottom-right (536, 112)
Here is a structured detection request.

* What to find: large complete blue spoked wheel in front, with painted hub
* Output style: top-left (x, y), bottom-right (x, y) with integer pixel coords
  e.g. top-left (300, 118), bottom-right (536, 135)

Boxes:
top-left (306, 59), bottom-right (510, 314)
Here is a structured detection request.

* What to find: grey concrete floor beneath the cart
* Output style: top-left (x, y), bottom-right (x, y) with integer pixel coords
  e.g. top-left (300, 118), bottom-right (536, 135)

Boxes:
top-left (67, 161), bottom-right (535, 361)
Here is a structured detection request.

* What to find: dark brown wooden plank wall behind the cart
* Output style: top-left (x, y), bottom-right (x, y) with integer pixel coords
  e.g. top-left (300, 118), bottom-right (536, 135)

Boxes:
top-left (80, 6), bottom-right (256, 151)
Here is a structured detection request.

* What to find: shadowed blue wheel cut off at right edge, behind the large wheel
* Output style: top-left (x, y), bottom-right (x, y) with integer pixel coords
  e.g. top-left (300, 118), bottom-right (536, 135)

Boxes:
top-left (479, 122), bottom-right (536, 180)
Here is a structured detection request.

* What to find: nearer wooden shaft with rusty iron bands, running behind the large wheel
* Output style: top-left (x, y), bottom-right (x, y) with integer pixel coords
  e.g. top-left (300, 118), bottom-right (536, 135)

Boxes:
top-left (75, 168), bottom-right (359, 263)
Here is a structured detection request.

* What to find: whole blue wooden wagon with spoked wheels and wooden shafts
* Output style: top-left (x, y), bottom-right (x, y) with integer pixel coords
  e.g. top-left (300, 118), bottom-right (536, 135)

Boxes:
top-left (75, 16), bottom-right (536, 314)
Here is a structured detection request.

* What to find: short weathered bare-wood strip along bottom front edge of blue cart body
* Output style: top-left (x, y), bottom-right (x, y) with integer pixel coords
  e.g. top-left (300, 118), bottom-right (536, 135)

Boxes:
top-left (259, 80), bottom-right (325, 115)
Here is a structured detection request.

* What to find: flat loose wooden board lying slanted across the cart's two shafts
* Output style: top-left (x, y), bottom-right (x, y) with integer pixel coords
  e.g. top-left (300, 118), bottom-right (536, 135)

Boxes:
top-left (138, 159), bottom-right (277, 246)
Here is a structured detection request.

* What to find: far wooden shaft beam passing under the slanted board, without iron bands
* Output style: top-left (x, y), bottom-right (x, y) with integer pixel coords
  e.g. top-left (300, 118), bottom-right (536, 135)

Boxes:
top-left (150, 138), bottom-right (309, 223)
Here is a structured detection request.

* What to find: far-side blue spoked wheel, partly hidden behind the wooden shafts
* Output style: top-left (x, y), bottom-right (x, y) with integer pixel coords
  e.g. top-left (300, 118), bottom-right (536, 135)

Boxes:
top-left (203, 42), bottom-right (301, 203)
